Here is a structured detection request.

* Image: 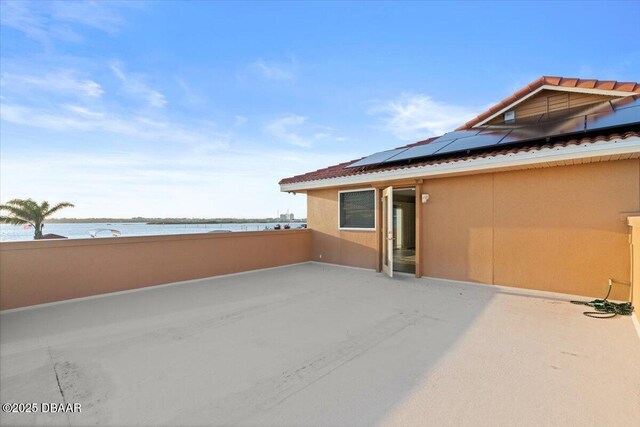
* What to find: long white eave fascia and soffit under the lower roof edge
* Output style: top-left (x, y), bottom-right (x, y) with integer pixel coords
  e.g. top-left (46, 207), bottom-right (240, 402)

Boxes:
top-left (280, 136), bottom-right (640, 192)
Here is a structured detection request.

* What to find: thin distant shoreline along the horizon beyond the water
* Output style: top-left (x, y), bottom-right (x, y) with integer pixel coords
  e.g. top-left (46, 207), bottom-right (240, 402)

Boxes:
top-left (46, 217), bottom-right (307, 225)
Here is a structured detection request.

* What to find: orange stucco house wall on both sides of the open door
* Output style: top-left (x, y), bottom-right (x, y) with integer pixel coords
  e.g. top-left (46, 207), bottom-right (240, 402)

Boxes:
top-left (308, 159), bottom-right (640, 300)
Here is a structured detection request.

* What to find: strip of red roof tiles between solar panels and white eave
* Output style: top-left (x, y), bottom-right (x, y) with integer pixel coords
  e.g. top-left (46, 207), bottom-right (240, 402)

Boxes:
top-left (279, 131), bottom-right (640, 185)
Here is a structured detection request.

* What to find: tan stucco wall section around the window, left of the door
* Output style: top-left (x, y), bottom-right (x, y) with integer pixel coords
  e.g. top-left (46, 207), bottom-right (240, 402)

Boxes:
top-left (307, 189), bottom-right (377, 269)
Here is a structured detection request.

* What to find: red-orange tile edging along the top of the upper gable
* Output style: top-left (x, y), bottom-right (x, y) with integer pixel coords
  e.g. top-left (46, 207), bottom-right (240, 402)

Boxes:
top-left (456, 76), bottom-right (640, 130)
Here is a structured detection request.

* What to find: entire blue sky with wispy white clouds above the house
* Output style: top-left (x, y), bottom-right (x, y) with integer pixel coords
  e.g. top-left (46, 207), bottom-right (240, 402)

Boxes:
top-left (0, 1), bottom-right (640, 217)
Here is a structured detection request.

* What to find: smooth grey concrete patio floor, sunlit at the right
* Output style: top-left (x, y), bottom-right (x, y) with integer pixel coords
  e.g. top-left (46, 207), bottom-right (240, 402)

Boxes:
top-left (0, 263), bottom-right (640, 426)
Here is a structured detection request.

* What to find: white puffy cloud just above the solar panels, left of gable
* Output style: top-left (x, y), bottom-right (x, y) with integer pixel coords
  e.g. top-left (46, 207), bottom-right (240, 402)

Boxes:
top-left (369, 94), bottom-right (477, 140)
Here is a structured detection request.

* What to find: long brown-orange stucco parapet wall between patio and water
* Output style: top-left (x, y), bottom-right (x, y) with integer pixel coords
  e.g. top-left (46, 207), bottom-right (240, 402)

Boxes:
top-left (0, 230), bottom-right (311, 310)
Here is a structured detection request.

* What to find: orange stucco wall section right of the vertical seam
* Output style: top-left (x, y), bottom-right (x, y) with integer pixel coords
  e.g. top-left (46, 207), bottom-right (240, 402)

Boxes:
top-left (494, 160), bottom-right (640, 299)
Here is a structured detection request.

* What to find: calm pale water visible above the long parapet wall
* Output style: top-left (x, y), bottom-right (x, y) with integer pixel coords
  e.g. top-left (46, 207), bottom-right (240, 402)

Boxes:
top-left (0, 222), bottom-right (301, 242)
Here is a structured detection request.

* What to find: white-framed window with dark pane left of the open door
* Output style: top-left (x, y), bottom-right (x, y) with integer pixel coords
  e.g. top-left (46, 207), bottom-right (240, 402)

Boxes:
top-left (338, 189), bottom-right (376, 230)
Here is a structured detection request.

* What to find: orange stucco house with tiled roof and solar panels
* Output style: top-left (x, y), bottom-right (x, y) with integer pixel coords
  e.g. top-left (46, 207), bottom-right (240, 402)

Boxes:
top-left (280, 77), bottom-right (640, 305)
